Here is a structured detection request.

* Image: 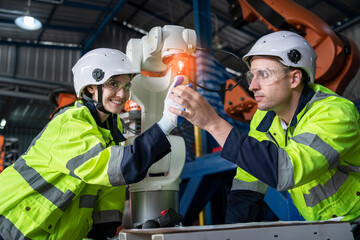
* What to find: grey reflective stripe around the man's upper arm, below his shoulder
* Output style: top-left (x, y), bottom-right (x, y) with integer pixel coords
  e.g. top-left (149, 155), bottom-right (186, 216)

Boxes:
top-left (292, 133), bottom-right (340, 170)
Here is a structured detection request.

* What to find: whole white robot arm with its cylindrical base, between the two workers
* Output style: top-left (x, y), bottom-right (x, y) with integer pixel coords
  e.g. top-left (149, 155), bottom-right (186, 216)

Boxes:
top-left (126, 25), bottom-right (196, 227)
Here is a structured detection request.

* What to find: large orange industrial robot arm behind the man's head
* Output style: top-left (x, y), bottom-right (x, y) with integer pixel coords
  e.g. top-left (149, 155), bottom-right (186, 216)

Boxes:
top-left (224, 0), bottom-right (360, 122)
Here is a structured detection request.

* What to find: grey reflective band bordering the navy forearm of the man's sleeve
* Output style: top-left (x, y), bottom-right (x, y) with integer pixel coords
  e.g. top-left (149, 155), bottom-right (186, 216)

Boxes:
top-left (276, 148), bottom-right (295, 191)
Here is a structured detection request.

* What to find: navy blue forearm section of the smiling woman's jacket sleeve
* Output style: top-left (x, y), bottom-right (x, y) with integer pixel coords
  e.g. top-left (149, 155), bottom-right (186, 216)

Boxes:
top-left (121, 124), bottom-right (171, 184)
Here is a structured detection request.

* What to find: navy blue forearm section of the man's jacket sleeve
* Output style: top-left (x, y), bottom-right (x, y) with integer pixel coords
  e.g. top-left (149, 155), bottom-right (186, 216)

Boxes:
top-left (220, 128), bottom-right (278, 189)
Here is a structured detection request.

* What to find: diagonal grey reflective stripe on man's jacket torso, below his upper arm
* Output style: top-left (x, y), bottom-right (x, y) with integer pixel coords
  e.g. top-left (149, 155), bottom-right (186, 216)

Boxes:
top-left (304, 170), bottom-right (349, 207)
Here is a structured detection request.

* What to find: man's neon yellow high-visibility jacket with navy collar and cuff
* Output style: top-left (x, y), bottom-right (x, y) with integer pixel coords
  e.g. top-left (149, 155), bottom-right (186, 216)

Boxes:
top-left (221, 84), bottom-right (360, 221)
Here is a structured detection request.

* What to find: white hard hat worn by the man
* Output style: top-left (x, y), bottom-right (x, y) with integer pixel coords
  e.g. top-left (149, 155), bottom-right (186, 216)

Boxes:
top-left (243, 31), bottom-right (317, 84)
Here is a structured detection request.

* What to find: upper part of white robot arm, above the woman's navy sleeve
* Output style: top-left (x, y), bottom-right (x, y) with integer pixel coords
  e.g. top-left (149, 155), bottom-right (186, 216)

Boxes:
top-left (126, 25), bottom-right (196, 131)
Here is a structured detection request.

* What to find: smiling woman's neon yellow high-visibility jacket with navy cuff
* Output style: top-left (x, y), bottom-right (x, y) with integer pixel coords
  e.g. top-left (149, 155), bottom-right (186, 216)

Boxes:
top-left (0, 101), bottom-right (170, 240)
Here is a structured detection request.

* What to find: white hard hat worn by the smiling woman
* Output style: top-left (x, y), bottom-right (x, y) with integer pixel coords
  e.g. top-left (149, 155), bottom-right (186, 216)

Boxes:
top-left (72, 48), bottom-right (140, 97)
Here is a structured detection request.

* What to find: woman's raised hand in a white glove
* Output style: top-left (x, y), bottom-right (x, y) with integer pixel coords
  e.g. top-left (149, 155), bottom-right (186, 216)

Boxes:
top-left (158, 76), bottom-right (185, 135)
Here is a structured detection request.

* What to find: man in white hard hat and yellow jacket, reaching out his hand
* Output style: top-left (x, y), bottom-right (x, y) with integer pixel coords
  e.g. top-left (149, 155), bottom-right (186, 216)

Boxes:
top-left (169, 31), bottom-right (360, 223)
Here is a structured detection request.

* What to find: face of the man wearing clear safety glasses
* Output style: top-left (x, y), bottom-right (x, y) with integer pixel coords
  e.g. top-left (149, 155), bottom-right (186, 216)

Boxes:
top-left (249, 57), bottom-right (291, 112)
